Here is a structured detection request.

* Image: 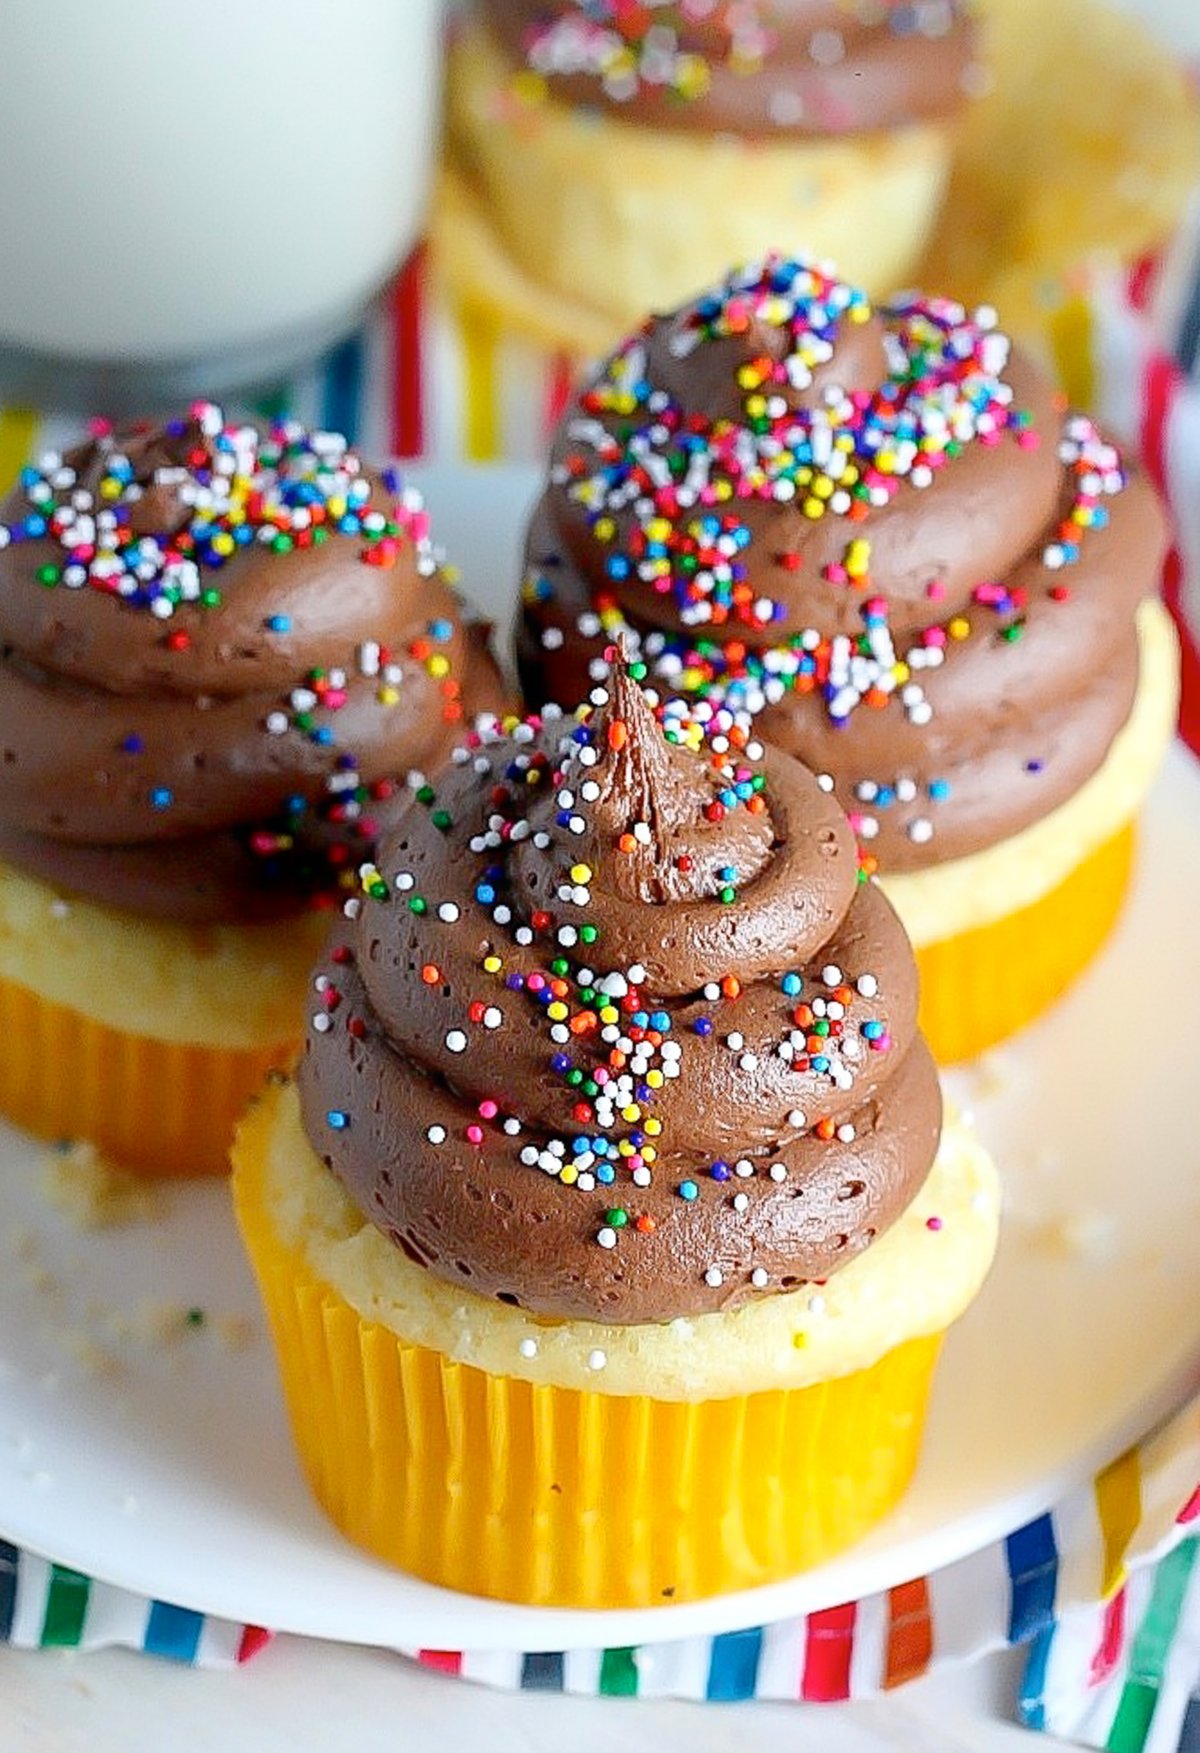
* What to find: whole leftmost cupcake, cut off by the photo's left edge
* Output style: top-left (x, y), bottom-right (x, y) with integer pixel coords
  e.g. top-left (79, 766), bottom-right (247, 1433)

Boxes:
top-left (0, 405), bottom-right (501, 1175)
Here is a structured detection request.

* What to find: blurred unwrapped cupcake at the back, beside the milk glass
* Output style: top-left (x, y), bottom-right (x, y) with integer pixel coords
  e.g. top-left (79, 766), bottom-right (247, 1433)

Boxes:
top-left (434, 0), bottom-right (981, 352)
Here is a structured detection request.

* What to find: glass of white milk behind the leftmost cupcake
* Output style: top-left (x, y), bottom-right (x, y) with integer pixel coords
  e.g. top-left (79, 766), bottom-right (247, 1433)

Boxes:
top-left (0, 0), bottom-right (441, 412)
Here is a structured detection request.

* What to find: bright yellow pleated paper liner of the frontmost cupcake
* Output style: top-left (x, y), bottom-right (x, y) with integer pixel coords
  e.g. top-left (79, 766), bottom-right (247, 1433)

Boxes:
top-left (233, 1100), bottom-right (941, 1608)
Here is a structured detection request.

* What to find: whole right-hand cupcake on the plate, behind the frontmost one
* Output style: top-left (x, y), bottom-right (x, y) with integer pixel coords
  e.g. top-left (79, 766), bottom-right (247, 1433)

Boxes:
top-left (519, 256), bottom-right (1175, 1061)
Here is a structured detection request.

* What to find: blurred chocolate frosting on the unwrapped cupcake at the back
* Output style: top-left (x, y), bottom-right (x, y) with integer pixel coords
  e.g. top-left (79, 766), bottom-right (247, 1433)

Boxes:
top-left (482, 0), bottom-right (976, 137)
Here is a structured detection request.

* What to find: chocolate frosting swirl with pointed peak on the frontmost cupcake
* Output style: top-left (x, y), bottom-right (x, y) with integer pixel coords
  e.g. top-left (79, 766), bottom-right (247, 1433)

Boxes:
top-left (300, 663), bottom-right (941, 1322)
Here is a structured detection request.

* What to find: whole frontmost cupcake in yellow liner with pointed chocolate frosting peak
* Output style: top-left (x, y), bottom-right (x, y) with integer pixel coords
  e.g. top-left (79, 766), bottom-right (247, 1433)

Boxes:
top-left (233, 664), bottom-right (997, 1608)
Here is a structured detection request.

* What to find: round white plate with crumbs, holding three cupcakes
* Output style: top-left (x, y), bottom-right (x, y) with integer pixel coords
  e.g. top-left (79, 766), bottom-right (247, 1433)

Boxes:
top-left (0, 470), bottom-right (1200, 1650)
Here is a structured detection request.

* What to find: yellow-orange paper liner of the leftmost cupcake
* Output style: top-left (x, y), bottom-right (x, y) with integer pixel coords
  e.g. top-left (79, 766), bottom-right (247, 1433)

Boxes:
top-left (0, 978), bottom-right (298, 1176)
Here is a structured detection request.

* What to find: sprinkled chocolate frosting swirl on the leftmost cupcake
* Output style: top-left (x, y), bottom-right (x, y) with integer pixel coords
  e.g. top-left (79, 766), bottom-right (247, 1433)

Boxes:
top-left (0, 405), bottom-right (501, 919)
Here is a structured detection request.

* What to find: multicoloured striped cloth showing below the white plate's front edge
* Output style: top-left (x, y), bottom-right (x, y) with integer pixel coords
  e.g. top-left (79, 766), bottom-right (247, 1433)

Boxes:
top-left (0, 1402), bottom-right (1200, 1753)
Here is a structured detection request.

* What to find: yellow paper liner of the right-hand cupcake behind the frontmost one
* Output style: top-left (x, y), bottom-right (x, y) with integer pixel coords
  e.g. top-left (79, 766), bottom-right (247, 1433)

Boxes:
top-left (916, 822), bottom-right (1135, 1064)
